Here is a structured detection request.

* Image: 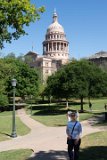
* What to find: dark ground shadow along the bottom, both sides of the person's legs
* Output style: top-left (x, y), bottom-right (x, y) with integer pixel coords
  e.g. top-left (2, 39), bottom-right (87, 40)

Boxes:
top-left (26, 146), bottom-right (107, 160)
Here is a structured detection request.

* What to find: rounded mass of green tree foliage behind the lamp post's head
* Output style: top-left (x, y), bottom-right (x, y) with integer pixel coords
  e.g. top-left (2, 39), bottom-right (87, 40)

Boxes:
top-left (0, 57), bottom-right (39, 98)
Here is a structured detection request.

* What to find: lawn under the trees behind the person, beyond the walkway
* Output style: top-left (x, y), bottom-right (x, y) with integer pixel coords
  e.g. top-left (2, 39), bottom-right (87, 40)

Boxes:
top-left (27, 99), bottom-right (107, 126)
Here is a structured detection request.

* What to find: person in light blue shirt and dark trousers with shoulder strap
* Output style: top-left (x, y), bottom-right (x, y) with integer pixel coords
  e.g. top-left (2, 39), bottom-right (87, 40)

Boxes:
top-left (66, 112), bottom-right (82, 160)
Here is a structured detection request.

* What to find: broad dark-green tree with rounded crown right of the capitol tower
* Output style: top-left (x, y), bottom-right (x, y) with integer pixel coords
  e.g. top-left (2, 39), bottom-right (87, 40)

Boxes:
top-left (46, 60), bottom-right (107, 111)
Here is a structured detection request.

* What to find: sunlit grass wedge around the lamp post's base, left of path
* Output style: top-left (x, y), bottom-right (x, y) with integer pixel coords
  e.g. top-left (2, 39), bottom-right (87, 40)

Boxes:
top-left (0, 112), bottom-right (30, 141)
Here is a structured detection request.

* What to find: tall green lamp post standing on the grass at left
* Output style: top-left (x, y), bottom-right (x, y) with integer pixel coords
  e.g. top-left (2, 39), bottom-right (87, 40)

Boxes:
top-left (11, 79), bottom-right (17, 138)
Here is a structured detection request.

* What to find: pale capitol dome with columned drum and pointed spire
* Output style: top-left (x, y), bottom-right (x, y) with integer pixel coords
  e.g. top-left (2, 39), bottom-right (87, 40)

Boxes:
top-left (43, 11), bottom-right (69, 63)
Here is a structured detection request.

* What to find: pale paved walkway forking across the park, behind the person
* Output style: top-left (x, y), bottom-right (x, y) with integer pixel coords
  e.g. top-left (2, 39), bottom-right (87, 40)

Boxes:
top-left (0, 109), bottom-right (107, 160)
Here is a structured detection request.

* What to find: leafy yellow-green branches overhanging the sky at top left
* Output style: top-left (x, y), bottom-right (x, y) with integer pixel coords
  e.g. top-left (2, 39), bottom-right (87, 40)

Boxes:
top-left (0, 0), bottom-right (44, 48)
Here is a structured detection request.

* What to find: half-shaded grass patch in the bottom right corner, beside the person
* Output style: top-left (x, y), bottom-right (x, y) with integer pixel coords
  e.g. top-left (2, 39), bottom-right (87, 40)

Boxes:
top-left (80, 131), bottom-right (107, 160)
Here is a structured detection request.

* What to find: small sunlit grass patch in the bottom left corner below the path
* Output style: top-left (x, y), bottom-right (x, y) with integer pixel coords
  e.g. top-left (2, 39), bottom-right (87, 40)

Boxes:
top-left (0, 149), bottom-right (32, 160)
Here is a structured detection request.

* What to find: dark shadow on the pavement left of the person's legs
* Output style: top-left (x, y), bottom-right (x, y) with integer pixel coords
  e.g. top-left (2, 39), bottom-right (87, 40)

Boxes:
top-left (26, 150), bottom-right (68, 160)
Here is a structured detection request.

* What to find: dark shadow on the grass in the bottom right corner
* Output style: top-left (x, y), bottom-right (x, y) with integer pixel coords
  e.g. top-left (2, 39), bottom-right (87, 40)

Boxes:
top-left (79, 146), bottom-right (107, 160)
